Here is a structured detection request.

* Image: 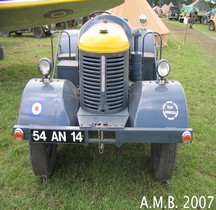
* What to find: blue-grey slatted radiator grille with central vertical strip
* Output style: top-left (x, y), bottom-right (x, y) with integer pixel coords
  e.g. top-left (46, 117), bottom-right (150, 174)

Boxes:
top-left (80, 51), bottom-right (129, 113)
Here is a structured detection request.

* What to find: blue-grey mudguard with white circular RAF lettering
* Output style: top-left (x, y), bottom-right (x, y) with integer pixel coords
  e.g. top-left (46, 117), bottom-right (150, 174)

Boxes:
top-left (129, 81), bottom-right (189, 128)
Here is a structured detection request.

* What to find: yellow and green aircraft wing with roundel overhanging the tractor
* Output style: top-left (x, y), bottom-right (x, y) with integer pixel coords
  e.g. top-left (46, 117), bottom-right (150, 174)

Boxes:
top-left (0, 0), bottom-right (124, 32)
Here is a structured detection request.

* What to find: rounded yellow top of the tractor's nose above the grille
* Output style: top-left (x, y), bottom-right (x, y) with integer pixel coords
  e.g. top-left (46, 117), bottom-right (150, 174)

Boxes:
top-left (79, 21), bottom-right (129, 53)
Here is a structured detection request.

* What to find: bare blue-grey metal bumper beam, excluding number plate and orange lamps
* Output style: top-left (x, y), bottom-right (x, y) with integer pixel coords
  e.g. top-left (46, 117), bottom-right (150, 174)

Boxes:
top-left (13, 125), bottom-right (193, 144)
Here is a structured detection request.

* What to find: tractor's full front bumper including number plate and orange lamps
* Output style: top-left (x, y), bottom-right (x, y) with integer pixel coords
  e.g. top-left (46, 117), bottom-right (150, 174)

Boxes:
top-left (13, 125), bottom-right (193, 145)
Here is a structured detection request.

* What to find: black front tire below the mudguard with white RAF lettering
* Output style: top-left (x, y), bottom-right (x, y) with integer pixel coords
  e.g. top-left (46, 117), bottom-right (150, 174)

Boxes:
top-left (151, 143), bottom-right (178, 181)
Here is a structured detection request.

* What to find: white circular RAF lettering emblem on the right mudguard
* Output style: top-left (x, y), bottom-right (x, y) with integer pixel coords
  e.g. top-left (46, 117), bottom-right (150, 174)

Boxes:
top-left (163, 101), bottom-right (179, 120)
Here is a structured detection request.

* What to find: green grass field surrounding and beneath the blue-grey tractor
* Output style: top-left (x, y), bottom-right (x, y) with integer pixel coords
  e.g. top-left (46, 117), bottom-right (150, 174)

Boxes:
top-left (0, 20), bottom-right (216, 210)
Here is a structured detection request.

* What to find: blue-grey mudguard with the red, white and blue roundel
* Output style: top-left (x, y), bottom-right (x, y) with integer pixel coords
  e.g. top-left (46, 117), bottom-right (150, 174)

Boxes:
top-left (18, 79), bottom-right (79, 126)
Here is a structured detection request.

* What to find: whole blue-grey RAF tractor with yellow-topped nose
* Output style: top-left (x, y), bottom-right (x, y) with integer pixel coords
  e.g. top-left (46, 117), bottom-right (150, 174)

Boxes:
top-left (13, 12), bottom-right (193, 181)
